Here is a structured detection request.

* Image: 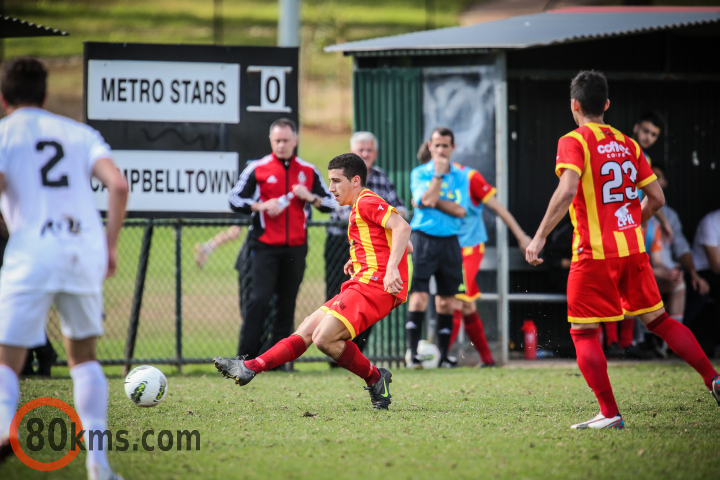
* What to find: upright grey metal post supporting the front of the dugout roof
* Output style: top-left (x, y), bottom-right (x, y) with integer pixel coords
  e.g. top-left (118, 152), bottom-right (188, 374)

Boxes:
top-left (495, 51), bottom-right (510, 365)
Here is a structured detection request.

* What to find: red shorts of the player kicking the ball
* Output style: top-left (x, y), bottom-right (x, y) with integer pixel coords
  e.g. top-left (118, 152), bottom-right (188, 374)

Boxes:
top-left (320, 280), bottom-right (403, 338)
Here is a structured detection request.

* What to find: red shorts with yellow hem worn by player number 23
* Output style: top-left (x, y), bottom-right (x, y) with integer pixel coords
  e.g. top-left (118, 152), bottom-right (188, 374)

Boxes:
top-left (568, 253), bottom-right (663, 323)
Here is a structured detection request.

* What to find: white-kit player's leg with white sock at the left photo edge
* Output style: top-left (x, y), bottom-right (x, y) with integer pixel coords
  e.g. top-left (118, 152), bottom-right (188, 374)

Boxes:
top-left (0, 345), bottom-right (27, 463)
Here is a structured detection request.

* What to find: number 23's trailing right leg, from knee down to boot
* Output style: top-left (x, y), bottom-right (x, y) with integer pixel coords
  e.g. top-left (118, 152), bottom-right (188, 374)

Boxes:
top-left (639, 307), bottom-right (720, 407)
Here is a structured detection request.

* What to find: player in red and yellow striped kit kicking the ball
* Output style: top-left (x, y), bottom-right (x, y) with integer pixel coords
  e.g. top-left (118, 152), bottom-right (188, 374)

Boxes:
top-left (213, 153), bottom-right (412, 410)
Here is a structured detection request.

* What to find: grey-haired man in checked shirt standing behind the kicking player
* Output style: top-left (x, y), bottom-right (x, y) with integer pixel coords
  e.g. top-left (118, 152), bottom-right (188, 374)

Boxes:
top-left (325, 132), bottom-right (407, 352)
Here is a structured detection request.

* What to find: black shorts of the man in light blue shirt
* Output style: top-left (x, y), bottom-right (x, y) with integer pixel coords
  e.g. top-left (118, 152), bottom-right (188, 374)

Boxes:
top-left (410, 232), bottom-right (463, 297)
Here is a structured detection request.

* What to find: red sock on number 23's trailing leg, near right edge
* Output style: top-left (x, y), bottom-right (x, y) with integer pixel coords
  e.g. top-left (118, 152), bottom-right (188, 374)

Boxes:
top-left (647, 312), bottom-right (718, 389)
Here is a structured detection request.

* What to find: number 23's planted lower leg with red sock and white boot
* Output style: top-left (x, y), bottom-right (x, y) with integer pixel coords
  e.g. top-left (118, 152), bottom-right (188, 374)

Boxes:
top-left (570, 323), bottom-right (625, 429)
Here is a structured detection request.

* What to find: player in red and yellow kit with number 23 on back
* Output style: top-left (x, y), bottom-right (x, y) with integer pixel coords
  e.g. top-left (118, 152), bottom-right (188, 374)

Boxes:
top-left (525, 71), bottom-right (720, 429)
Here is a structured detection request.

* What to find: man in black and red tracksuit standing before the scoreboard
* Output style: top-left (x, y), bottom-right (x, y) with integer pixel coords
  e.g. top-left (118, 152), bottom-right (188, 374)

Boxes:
top-left (230, 118), bottom-right (337, 358)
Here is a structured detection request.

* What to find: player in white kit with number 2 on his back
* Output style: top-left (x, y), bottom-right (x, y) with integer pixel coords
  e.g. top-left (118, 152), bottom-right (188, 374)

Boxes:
top-left (0, 57), bottom-right (128, 480)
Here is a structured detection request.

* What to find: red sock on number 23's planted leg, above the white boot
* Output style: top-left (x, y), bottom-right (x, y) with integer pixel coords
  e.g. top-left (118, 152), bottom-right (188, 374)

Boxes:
top-left (570, 328), bottom-right (619, 418)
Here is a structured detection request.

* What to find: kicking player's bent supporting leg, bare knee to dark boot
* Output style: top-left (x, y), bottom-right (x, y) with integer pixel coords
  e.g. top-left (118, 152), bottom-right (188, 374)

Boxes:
top-left (313, 315), bottom-right (392, 410)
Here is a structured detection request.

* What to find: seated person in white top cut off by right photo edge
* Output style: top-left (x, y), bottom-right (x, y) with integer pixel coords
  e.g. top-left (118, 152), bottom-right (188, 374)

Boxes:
top-left (685, 209), bottom-right (720, 355)
